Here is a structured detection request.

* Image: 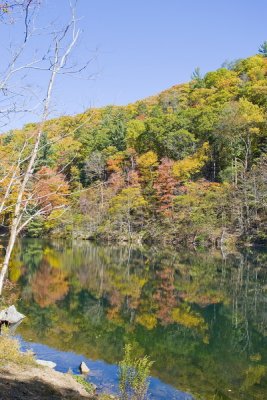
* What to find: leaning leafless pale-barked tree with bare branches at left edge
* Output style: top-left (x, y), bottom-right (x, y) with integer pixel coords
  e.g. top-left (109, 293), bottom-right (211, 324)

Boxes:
top-left (0, 0), bottom-right (88, 294)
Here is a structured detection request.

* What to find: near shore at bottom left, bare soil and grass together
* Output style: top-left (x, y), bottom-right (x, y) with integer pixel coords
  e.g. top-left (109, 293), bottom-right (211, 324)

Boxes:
top-left (0, 335), bottom-right (115, 400)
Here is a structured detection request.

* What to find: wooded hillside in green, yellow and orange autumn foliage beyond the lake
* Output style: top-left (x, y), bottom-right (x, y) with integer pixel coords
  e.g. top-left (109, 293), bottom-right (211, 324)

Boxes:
top-left (0, 53), bottom-right (267, 245)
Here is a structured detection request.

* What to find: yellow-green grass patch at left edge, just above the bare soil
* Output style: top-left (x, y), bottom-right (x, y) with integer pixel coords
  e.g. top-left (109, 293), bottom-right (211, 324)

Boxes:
top-left (0, 335), bottom-right (35, 367)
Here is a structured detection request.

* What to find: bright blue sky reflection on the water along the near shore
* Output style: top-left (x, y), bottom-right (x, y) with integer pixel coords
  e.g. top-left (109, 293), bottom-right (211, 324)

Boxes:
top-left (19, 338), bottom-right (193, 400)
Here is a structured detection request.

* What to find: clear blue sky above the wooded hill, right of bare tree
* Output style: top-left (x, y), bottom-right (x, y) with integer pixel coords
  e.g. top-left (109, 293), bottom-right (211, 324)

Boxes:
top-left (2, 0), bottom-right (267, 126)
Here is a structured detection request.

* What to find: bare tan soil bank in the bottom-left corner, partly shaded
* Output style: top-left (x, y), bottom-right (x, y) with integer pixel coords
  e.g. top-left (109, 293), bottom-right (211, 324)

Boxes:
top-left (0, 364), bottom-right (95, 400)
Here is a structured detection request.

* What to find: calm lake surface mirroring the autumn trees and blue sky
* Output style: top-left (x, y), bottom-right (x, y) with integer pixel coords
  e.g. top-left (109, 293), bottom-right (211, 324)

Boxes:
top-left (5, 239), bottom-right (267, 400)
